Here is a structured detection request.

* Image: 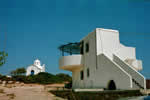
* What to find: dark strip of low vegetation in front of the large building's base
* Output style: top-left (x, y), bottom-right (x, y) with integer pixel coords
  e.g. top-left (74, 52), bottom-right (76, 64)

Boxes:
top-left (50, 90), bottom-right (142, 100)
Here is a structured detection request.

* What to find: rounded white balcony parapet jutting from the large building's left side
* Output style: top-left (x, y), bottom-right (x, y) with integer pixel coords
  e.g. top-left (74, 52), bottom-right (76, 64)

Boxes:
top-left (59, 55), bottom-right (83, 71)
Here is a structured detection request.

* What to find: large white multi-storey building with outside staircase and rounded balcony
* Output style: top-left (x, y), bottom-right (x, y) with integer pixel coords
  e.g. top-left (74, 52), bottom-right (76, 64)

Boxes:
top-left (59, 28), bottom-right (146, 89)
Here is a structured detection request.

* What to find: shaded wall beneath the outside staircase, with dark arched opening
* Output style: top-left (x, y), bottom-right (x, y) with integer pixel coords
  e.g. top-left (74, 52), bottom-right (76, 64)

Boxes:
top-left (94, 54), bottom-right (132, 89)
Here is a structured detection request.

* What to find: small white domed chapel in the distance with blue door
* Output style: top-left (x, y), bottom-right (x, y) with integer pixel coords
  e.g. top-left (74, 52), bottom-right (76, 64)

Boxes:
top-left (26, 59), bottom-right (45, 76)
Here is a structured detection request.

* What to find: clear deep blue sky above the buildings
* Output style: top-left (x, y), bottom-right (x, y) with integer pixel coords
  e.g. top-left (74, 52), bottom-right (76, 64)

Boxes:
top-left (0, 0), bottom-right (150, 78)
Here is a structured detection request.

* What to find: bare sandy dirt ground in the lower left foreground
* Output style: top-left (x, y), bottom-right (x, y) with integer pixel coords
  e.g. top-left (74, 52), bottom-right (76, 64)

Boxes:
top-left (0, 84), bottom-right (64, 100)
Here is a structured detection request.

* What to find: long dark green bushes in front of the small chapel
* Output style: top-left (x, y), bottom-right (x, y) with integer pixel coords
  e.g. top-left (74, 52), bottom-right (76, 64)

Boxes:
top-left (9, 72), bottom-right (72, 84)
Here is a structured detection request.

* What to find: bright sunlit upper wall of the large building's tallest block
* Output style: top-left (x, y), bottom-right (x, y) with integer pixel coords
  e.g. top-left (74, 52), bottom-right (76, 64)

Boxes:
top-left (96, 28), bottom-right (120, 59)
